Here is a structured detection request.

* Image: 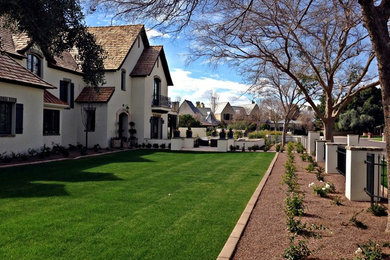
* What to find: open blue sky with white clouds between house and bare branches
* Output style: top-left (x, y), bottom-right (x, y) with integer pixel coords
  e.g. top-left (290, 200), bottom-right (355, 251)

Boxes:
top-left (85, 9), bottom-right (251, 105)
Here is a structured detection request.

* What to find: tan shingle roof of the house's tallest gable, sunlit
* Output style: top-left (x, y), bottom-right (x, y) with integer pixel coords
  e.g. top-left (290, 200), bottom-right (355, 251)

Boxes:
top-left (88, 25), bottom-right (148, 70)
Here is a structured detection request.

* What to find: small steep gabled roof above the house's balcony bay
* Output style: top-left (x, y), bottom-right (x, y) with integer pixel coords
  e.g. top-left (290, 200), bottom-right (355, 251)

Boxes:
top-left (130, 46), bottom-right (173, 86)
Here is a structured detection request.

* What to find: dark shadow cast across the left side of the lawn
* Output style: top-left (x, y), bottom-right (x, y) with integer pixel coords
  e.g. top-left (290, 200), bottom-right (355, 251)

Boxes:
top-left (0, 151), bottom-right (152, 198)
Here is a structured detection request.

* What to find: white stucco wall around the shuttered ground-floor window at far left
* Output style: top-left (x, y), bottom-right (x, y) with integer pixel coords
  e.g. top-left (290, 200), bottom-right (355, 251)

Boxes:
top-left (0, 82), bottom-right (43, 153)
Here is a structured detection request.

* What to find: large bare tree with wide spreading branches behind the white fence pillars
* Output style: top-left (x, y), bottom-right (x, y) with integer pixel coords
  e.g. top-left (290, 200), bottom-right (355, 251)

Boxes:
top-left (90, 0), bottom-right (378, 140)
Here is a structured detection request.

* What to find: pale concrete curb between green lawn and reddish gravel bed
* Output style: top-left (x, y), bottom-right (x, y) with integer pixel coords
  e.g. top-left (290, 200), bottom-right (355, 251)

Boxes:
top-left (217, 153), bottom-right (279, 260)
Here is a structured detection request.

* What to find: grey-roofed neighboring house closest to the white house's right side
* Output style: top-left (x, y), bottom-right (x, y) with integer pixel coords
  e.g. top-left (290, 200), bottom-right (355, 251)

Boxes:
top-left (179, 100), bottom-right (220, 126)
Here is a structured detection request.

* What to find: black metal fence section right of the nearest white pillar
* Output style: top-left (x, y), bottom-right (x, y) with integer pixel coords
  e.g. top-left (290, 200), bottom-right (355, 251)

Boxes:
top-left (364, 153), bottom-right (387, 205)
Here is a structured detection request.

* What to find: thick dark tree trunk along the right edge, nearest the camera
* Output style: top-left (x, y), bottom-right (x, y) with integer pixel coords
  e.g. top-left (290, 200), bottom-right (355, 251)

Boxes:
top-left (358, 0), bottom-right (390, 232)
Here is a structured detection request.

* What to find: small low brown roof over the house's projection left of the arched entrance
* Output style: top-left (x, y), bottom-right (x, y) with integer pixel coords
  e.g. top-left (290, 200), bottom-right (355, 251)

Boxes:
top-left (75, 87), bottom-right (115, 103)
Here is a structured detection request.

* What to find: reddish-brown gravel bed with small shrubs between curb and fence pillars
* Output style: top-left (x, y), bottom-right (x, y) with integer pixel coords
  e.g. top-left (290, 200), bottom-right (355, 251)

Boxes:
top-left (233, 153), bottom-right (390, 259)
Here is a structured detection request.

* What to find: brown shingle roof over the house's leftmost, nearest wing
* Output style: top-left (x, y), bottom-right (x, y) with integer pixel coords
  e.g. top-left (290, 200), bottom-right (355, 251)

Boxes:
top-left (0, 53), bottom-right (56, 89)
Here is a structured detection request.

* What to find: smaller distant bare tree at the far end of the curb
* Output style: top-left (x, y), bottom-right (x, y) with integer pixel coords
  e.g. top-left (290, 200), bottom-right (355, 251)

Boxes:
top-left (252, 71), bottom-right (305, 147)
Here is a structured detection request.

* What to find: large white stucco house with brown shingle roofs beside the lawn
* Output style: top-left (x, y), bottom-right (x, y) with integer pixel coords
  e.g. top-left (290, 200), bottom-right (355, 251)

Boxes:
top-left (0, 25), bottom-right (173, 153)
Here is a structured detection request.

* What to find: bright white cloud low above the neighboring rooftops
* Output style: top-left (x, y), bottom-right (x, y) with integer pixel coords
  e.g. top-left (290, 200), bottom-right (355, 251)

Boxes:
top-left (168, 69), bottom-right (251, 106)
